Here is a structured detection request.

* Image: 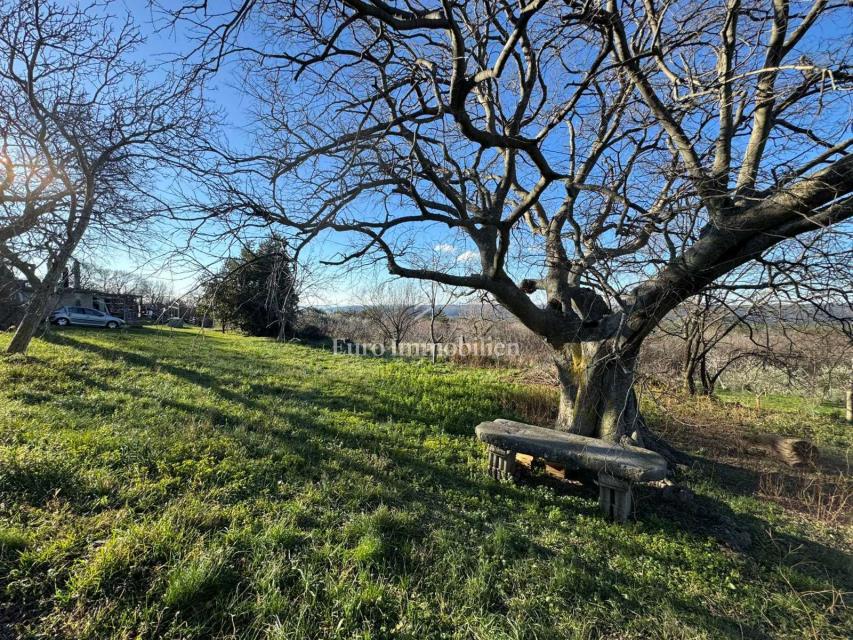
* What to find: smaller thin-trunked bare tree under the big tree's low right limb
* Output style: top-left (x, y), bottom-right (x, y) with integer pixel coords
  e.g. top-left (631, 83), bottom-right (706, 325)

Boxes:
top-left (658, 231), bottom-right (853, 395)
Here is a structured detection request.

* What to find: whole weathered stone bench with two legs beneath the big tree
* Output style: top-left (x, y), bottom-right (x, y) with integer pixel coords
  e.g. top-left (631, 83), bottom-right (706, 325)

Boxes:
top-left (475, 419), bottom-right (667, 522)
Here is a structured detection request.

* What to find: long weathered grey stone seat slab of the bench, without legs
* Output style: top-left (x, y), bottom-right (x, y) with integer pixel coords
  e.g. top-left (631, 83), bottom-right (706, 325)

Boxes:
top-left (475, 419), bottom-right (667, 482)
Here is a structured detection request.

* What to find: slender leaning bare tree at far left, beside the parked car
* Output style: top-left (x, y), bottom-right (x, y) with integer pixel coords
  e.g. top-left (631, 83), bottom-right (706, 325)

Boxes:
top-left (0, 0), bottom-right (204, 353)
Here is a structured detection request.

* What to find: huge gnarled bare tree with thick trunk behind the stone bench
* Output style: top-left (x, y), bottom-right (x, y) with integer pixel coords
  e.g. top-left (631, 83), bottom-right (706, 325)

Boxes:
top-left (180, 0), bottom-right (853, 460)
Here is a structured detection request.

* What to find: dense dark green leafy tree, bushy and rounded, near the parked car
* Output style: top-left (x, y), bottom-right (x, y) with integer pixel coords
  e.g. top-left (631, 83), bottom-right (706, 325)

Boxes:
top-left (203, 236), bottom-right (298, 340)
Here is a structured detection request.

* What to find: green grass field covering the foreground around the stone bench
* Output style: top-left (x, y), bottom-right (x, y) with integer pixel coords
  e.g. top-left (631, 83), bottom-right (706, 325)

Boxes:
top-left (0, 329), bottom-right (853, 640)
